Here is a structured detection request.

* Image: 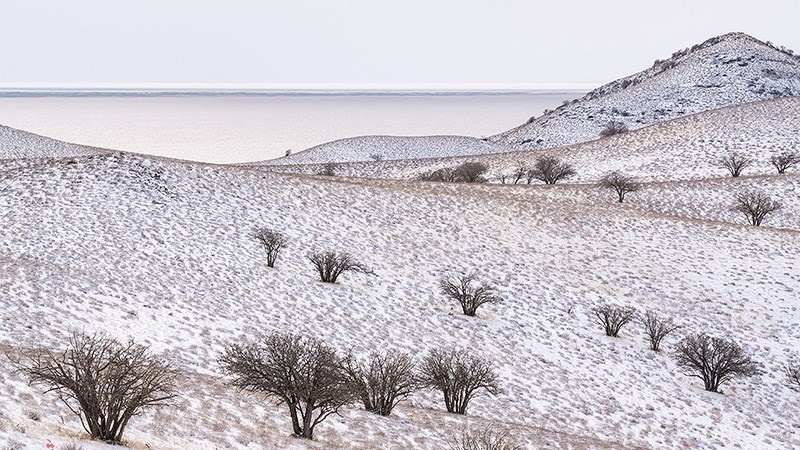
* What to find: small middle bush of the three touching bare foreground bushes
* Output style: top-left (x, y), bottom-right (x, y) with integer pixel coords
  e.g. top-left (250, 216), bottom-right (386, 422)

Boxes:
top-left (345, 352), bottom-right (419, 416)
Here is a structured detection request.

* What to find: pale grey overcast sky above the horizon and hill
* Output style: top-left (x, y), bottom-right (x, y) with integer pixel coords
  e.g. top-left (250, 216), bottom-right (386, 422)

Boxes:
top-left (0, 0), bottom-right (800, 88)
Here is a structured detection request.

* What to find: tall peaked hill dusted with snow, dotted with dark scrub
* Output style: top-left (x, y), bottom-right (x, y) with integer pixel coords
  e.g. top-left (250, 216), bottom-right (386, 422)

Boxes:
top-left (490, 33), bottom-right (800, 149)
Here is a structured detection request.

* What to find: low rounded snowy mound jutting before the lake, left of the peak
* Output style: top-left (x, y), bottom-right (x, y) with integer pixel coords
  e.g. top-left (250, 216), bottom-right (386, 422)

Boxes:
top-left (256, 136), bottom-right (510, 165)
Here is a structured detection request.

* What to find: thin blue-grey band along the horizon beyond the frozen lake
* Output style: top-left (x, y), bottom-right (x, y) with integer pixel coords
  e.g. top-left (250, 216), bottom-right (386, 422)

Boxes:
top-left (0, 88), bottom-right (588, 98)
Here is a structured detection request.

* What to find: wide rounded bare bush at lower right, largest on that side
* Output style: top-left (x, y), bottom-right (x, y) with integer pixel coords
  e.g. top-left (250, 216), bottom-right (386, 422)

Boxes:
top-left (675, 333), bottom-right (761, 392)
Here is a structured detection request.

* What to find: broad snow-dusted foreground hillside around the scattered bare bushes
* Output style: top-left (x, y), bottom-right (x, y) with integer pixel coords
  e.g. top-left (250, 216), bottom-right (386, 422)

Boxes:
top-left (0, 155), bottom-right (800, 450)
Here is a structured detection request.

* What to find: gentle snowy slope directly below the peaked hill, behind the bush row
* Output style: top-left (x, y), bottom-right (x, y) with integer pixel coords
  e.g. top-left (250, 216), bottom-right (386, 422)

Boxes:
top-left (253, 97), bottom-right (800, 182)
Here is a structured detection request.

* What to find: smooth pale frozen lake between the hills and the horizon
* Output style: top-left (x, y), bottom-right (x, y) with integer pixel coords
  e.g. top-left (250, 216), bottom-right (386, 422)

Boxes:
top-left (0, 91), bottom-right (583, 163)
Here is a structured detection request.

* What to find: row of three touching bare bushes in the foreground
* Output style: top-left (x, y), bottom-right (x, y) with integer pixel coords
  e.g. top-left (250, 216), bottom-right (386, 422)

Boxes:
top-left (220, 332), bottom-right (500, 439)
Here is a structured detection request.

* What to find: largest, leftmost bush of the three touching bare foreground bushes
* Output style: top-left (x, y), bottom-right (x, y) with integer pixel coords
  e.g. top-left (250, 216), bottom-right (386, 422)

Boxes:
top-left (220, 332), bottom-right (355, 439)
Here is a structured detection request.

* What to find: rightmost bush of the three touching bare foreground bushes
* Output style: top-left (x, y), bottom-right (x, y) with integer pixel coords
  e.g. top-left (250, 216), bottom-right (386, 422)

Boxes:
top-left (420, 349), bottom-right (500, 414)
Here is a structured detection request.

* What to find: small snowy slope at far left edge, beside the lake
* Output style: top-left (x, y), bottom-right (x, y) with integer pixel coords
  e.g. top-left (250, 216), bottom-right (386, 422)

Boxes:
top-left (0, 125), bottom-right (105, 159)
